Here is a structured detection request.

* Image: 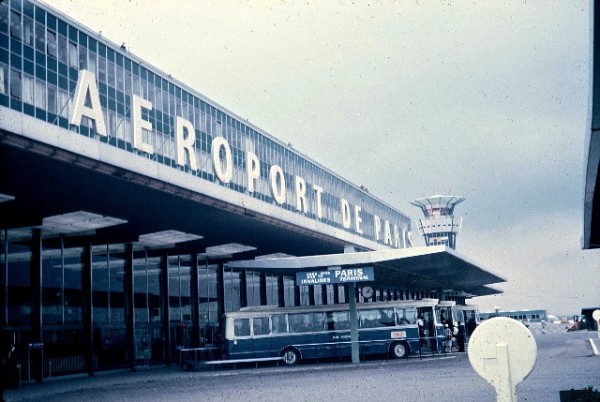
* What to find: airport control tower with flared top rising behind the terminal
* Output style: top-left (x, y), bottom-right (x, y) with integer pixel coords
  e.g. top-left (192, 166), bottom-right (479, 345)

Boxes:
top-left (411, 195), bottom-right (465, 249)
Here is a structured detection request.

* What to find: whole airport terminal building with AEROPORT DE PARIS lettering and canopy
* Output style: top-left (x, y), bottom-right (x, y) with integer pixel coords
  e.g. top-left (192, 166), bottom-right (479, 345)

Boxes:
top-left (0, 0), bottom-right (504, 381)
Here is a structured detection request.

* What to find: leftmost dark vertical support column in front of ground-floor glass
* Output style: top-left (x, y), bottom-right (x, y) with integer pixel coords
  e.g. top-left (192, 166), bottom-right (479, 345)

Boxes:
top-left (29, 229), bottom-right (44, 383)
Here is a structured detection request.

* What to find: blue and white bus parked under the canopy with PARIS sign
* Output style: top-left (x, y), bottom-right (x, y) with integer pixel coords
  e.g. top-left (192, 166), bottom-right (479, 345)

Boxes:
top-left (222, 299), bottom-right (444, 365)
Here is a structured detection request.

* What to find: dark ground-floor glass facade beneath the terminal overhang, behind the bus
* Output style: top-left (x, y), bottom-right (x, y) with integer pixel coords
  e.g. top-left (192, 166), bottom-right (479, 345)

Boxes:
top-left (0, 229), bottom-right (435, 377)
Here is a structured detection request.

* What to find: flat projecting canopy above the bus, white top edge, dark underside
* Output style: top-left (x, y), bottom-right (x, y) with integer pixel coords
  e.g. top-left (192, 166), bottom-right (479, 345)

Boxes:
top-left (229, 246), bottom-right (506, 296)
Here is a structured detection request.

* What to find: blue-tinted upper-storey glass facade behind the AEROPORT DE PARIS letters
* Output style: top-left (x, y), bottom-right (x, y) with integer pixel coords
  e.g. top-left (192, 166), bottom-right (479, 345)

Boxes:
top-left (0, 0), bottom-right (410, 247)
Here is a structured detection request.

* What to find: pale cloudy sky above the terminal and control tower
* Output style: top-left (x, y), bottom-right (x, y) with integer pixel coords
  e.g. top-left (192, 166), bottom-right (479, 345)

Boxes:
top-left (46, 0), bottom-right (600, 315)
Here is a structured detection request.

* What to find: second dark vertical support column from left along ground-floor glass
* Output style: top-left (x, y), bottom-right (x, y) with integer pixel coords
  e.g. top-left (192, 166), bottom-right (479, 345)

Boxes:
top-left (81, 240), bottom-right (94, 376)
